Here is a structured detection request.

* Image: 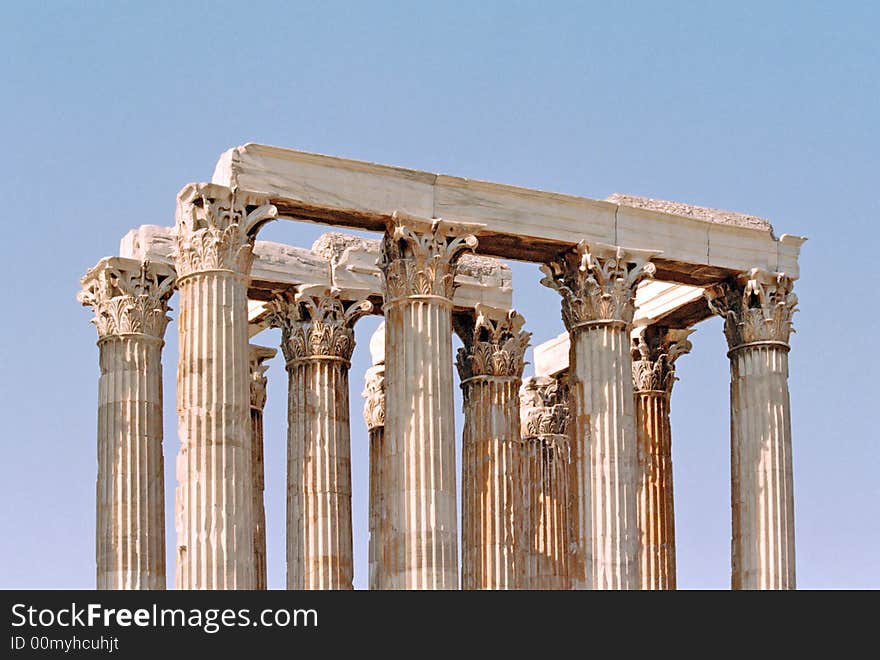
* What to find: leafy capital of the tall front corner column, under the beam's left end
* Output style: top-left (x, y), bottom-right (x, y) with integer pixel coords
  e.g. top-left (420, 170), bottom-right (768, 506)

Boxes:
top-left (174, 183), bottom-right (278, 278)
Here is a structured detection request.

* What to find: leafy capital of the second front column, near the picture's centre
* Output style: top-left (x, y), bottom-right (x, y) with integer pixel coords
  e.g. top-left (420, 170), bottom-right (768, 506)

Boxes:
top-left (378, 213), bottom-right (478, 303)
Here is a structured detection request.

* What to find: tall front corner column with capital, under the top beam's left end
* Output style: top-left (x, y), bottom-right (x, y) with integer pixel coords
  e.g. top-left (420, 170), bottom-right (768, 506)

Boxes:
top-left (174, 184), bottom-right (275, 589)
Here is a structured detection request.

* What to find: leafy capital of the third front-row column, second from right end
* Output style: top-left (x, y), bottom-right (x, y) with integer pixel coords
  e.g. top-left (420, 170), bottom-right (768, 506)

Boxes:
top-left (541, 241), bottom-right (658, 332)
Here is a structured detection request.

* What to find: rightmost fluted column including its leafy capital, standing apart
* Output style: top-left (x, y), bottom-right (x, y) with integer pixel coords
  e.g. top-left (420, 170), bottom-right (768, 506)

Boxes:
top-left (707, 269), bottom-right (797, 589)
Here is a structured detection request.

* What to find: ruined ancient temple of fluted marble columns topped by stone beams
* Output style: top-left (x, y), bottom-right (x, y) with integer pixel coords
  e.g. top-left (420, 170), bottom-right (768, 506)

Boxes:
top-left (79, 144), bottom-right (805, 589)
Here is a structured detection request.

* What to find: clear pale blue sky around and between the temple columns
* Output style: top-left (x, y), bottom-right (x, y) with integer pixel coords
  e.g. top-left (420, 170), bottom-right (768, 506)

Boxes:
top-left (0, 1), bottom-right (880, 588)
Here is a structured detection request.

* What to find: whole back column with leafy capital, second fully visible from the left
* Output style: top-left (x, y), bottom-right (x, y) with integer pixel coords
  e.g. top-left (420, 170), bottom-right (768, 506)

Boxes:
top-left (267, 290), bottom-right (373, 589)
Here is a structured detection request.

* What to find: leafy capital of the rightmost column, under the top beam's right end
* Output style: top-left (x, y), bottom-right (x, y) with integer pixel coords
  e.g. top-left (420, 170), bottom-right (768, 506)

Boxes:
top-left (706, 268), bottom-right (797, 350)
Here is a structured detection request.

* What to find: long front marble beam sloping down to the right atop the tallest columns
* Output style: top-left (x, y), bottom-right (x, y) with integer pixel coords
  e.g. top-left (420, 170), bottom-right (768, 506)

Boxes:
top-left (212, 144), bottom-right (805, 285)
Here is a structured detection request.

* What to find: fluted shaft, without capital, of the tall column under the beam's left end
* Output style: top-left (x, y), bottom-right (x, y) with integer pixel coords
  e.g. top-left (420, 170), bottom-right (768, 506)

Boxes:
top-left (177, 271), bottom-right (255, 589)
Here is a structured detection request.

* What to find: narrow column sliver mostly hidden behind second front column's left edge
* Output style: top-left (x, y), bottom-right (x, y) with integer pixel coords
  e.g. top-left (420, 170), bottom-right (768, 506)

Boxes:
top-left (363, 327), bottom-right (388, 590)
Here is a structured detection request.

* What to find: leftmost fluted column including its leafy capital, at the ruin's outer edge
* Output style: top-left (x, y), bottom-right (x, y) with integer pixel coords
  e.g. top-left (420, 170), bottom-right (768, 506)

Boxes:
top-left (77, 257), bottom-right (174, 589)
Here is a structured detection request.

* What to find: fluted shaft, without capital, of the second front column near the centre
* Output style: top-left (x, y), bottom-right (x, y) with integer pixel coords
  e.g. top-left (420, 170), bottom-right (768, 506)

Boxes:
top-left (385, 298), bottom-right (458, 589)
